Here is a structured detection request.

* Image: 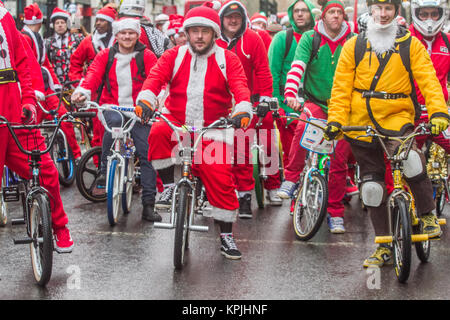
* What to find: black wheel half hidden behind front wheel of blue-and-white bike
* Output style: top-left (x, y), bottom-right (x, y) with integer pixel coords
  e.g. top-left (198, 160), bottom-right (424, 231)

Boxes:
top-left (76, 146), bottom-right (106, 202)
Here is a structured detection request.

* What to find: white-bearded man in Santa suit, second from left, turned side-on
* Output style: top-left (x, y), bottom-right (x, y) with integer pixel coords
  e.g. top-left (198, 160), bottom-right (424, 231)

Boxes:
top-left (22, 3), bottom-right (81, 162)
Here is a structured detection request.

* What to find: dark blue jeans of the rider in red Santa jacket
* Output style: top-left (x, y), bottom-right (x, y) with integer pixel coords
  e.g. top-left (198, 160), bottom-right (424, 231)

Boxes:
top-left (100, 111), bottom-right (156, 205)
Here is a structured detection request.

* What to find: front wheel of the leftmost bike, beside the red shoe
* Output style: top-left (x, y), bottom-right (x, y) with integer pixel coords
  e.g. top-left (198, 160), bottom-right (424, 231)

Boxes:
top-left (29, 192), bottom-right (53, 286)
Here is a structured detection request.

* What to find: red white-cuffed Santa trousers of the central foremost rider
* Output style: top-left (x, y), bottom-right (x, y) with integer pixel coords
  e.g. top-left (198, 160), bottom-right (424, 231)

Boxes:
top-left (148, 115), bottom-right (239, 222)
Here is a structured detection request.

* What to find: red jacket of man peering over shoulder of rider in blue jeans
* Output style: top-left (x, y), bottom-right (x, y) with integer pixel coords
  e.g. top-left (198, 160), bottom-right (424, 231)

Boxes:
top-left (69, 33), bottom-right (114, 81)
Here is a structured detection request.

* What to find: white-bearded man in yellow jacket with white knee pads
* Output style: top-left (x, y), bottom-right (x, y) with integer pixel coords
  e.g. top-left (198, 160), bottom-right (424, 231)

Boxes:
top-left (325, 0), bottom-right (450, 267)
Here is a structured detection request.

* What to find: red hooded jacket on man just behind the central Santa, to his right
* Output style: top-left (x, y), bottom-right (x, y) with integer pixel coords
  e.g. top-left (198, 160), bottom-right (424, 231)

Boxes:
top-left (216, 1), bottom-right (272, 101)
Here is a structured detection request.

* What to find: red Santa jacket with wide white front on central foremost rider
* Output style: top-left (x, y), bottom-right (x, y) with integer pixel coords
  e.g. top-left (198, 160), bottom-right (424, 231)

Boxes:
top-left (138, 45), bottom-right (252, 131)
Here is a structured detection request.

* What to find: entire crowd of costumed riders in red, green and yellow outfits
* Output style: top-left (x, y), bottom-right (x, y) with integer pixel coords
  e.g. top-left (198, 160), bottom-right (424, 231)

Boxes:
top-left (0, 0), bottom-right (450, 267)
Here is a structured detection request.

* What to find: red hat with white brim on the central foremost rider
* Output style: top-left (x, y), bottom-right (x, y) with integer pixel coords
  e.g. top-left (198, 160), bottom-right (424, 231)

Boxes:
top-left (183, 1), bottom-right (220, 37)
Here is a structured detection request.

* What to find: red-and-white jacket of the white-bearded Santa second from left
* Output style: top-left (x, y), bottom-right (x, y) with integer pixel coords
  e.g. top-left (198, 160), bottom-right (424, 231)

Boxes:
top-left (22, 25), bottom-right (61, 91)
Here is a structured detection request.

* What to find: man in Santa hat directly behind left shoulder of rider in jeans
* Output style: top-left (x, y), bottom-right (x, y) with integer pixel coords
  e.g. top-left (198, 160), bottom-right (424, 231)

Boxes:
top-left (69, 6), bottom-right (117, 147)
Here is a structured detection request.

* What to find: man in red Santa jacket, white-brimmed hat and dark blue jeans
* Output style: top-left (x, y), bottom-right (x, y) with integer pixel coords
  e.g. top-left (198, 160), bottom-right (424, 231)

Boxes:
top-left (72, 18), bottom-right (161, 221)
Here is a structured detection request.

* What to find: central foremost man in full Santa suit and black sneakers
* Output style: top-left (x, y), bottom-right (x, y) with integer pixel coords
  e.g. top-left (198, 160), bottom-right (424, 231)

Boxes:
top-left (137, 2), bottom-right (252, 259)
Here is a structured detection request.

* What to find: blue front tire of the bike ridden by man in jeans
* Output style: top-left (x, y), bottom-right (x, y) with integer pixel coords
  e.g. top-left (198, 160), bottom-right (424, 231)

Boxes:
top-left (106, 159), bottom-right (121, 226)
